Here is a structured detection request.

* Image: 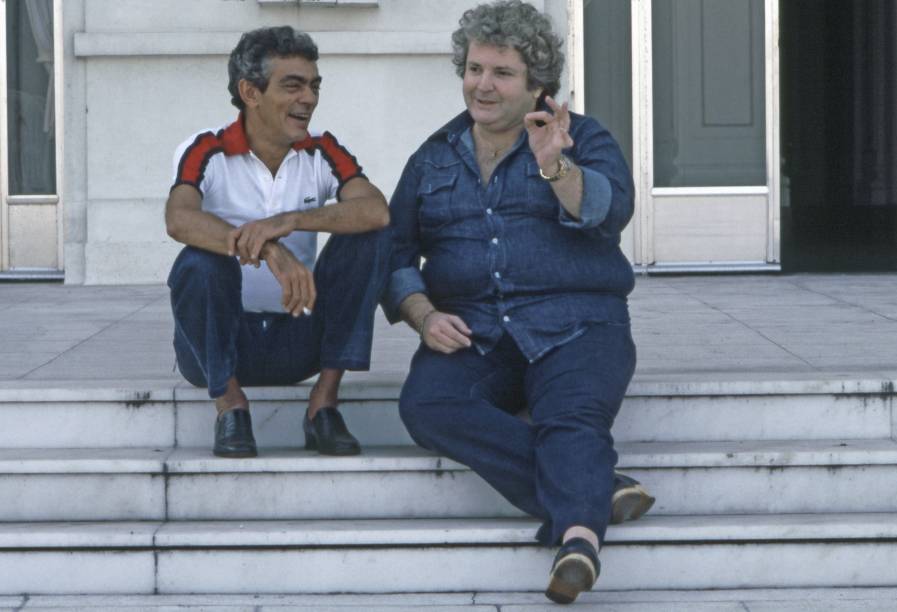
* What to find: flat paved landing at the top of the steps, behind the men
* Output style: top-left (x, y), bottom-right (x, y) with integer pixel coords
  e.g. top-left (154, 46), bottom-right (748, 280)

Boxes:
top-left (0, 274), bottom-right (897, 388)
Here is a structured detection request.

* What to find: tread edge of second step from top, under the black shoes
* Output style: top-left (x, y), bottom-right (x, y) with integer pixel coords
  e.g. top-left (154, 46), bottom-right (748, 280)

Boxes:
top-left (0, 439), bottom-right (897, 476)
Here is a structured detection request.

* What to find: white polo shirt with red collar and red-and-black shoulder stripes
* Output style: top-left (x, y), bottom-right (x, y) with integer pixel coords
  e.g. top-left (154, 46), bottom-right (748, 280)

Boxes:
top-left (172, 114), bottom-right (364, 312)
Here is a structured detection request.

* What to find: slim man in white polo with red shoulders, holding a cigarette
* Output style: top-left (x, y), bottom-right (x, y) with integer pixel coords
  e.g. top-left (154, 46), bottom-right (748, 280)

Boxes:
top-left (165, 26), bottom-right (389, 457)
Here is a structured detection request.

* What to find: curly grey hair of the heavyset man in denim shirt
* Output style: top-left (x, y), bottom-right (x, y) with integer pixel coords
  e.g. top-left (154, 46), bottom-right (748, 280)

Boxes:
top-left (452, 0), bottom-right (564, 96)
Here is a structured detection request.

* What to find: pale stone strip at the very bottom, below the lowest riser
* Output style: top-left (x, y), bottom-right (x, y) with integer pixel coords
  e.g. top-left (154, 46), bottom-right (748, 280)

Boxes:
top-left (0, 584), bottom-right (897, 612)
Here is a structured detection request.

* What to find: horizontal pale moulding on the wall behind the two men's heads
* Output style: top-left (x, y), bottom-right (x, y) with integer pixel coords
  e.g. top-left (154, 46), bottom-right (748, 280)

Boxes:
top-left (74, 32), bottom-right (451, 58)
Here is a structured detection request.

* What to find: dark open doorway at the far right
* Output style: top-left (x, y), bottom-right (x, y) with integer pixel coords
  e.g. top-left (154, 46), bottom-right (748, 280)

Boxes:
top-left (780, 0), bottom-right (897, 272)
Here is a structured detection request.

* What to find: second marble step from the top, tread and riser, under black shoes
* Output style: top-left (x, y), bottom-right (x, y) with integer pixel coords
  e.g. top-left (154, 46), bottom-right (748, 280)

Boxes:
top-left (0, 440), bottom-right (897, 521)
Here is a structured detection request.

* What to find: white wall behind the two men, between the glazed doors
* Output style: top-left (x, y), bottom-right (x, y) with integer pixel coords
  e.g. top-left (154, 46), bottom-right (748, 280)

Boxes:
top-left (63, 0), bottom-right (566, 284)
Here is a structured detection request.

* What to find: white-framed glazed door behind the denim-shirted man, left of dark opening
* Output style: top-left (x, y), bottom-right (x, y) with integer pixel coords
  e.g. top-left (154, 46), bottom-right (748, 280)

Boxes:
top-left (573, 0), bottom-right (779, 273)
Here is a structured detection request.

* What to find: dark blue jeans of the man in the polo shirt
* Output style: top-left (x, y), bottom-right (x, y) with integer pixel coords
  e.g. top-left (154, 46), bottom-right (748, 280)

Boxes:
top-left (168, 231), bottom-right (390, 398)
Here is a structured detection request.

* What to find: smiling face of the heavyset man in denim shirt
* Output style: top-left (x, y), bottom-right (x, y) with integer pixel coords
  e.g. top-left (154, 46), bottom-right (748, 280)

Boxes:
top-left (462, 41), bottom-right (540, 132)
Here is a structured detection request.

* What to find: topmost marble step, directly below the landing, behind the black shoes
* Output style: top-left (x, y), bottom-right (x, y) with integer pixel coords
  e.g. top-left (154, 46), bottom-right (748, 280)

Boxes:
top-left (0, 375), bottom-right (897, 448)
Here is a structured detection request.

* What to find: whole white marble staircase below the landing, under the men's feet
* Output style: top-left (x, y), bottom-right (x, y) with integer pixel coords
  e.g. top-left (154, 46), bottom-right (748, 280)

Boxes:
top-left (0, 376), bottom-right (897, 594)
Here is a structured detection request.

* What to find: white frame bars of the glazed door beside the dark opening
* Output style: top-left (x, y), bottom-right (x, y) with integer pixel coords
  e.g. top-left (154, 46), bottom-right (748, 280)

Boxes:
top-left (567, 0), bottom-right (781, 273)
